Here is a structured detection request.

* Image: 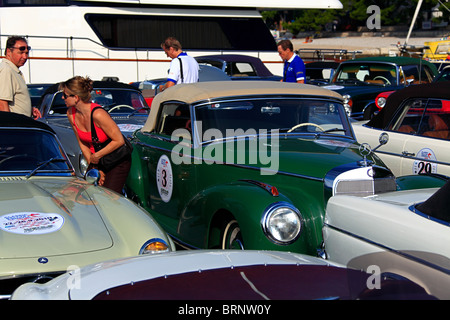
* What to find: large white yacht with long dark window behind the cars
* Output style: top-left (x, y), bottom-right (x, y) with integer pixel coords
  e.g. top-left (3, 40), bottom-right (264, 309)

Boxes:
top-left (0, 0), bottom-right (342, 83)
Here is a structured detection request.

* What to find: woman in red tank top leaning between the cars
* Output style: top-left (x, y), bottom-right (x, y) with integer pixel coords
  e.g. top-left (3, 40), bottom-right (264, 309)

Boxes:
top-left (59, 76), bottom-right (131, 193)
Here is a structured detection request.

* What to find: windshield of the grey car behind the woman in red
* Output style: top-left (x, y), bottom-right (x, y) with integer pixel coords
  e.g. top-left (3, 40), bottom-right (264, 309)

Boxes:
top-left (48, 89), bottom-right (150, 116)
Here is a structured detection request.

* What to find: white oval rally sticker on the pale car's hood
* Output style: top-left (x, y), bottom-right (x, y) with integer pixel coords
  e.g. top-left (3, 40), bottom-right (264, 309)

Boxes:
top-left (0, 212), bottom-right (64, 235)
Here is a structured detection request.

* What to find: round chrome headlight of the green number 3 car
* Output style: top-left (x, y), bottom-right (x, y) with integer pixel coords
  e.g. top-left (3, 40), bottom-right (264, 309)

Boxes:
top-left (261, 202), bottom-right (302, 245)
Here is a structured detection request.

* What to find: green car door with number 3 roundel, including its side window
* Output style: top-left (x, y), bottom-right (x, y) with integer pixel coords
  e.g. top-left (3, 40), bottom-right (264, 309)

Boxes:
top-left (143, 103), bottom-right (197, 235)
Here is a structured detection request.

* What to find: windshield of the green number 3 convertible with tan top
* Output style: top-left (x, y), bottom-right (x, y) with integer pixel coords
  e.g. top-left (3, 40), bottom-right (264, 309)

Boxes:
top-left (195, 98), bottom-right (351, 142)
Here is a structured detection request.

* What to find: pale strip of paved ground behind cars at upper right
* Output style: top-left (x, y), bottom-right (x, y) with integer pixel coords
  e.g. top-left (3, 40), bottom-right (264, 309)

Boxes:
top-left (292, 36), bottom-right (440, 55)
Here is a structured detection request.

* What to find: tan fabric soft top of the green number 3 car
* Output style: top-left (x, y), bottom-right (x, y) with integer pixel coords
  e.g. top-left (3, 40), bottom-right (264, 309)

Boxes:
top-left (142, 81), bottom-right (342, 132)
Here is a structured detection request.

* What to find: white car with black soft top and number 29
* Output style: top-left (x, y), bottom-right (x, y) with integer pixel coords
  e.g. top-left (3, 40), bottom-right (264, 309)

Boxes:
top-left (353, 81), bottom-right (450, 176)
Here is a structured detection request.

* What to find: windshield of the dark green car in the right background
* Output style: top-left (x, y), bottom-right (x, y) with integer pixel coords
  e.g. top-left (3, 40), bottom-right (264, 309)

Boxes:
top-left (332, 62), bottom-right (397, 86)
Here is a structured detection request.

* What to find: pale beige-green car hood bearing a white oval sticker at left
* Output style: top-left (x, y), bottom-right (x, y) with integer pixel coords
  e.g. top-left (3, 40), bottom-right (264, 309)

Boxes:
top-left (0, 178), bottom-right (113, 259)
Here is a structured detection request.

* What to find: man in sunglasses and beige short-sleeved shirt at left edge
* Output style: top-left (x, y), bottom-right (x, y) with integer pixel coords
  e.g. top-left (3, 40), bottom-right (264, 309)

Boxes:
top-left (0, 36), bottom-right (41, 119)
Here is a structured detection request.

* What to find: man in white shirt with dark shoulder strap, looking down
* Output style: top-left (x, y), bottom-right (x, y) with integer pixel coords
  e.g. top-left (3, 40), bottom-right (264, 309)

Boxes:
top-left (160, 37), bottom-right (199, 91)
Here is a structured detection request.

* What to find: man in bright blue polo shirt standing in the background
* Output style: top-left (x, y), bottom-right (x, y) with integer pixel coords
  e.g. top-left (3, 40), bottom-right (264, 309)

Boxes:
top-left (278, 40), bottom-right (305, 83)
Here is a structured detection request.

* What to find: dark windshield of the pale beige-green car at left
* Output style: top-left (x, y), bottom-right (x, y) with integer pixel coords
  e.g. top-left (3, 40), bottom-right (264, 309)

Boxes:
top-left (0, 128), bottom-right (71, 175)
